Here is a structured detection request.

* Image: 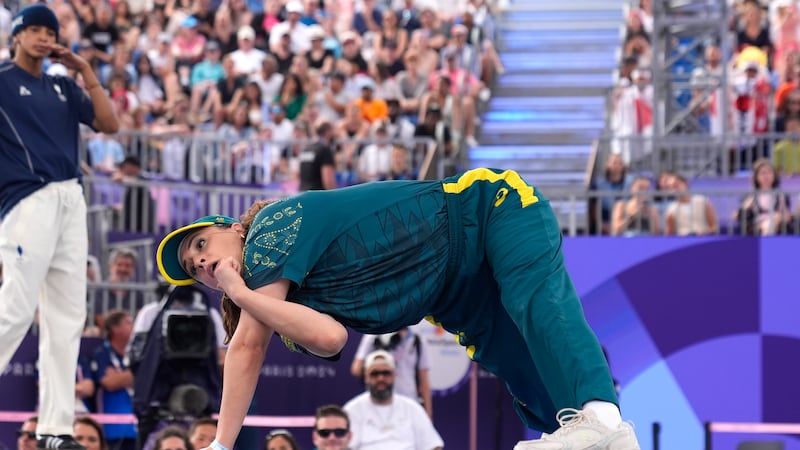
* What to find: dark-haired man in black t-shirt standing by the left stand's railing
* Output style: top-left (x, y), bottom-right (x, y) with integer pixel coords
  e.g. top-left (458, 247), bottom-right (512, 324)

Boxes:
top-left (300, 122), bottom-right (336, 191)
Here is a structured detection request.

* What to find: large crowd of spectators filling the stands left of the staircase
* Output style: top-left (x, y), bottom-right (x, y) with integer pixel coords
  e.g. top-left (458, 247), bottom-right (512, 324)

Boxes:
top-left (0, 0), bottom-right (503, 184)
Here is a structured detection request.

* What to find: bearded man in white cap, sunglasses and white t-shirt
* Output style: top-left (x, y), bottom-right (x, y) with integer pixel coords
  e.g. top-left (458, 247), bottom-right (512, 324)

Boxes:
top-left (344, 350), bottom-right (444, 450)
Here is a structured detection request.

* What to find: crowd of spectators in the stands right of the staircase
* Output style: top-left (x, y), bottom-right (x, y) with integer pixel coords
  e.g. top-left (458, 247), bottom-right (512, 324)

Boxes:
top-left (590, 0), bottom-right (800, 235)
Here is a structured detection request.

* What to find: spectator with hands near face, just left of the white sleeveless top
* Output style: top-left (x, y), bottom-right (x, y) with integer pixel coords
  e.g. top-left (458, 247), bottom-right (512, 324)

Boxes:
top-left (611, 177), bottom-right (661, 236)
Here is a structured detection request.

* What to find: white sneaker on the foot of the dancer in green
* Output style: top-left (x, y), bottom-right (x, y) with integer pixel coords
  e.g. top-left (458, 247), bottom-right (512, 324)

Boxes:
top-left (514, 408), bottom-right (640, 450)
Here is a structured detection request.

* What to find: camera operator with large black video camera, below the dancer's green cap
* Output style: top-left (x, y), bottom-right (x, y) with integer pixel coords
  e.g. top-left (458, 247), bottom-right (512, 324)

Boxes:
top-left (130, 286), bottom-right (225, 449)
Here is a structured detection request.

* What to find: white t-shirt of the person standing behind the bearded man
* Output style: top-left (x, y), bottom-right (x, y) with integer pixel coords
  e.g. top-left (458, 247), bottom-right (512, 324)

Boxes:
top-left (354, 330), bottom-right (431, 399)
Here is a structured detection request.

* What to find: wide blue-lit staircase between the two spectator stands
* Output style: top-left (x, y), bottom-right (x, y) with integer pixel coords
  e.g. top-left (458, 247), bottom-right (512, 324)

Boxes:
top-left (469, 0), bottom-right (625, 224)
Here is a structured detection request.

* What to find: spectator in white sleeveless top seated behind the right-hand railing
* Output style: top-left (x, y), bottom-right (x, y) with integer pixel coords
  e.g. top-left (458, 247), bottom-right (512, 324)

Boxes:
top-left (665, 175), bottom-right (719, 236)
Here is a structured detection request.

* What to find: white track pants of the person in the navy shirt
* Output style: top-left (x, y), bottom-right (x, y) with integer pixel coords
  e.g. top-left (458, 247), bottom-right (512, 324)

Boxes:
top-left (0, 180), bottom-right (88, 435)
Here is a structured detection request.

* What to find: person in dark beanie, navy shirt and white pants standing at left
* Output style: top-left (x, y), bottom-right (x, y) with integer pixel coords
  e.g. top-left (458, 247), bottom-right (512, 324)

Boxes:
top-left (0, 4), bottom-right (119, 450)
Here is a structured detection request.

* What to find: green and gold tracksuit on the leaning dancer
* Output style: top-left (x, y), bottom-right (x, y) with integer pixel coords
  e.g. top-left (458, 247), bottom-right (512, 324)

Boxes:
top-left (244, 169), bottom-right (617, 432)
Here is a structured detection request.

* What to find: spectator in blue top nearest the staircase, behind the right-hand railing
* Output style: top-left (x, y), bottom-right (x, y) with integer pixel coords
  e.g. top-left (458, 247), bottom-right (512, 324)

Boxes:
top-left (589, 153), bottom-right (633, 234)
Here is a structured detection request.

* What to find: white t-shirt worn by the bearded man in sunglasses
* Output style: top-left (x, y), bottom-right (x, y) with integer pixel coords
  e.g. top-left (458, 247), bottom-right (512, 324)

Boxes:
top-left (344, 392), bottom-right (444, 450)
